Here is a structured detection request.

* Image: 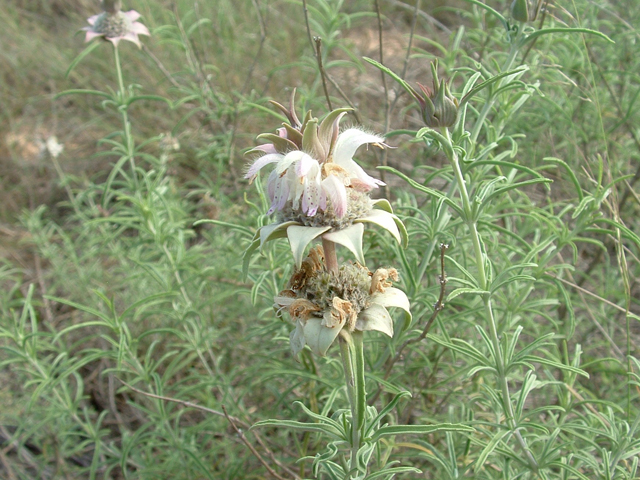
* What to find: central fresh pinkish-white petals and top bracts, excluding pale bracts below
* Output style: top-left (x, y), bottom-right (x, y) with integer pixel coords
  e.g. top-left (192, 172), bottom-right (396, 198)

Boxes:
top-left (245, 91), bottom-right (384, 221)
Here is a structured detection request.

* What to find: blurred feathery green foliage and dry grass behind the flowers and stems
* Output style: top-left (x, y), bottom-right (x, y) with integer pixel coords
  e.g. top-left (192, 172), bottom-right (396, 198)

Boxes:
top-left (0, 0), bottom-right (640, 479)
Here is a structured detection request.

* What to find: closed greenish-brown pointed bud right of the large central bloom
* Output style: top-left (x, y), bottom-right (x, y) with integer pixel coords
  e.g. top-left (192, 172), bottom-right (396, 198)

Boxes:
top-left (413, 61), bottom-right (459, 128)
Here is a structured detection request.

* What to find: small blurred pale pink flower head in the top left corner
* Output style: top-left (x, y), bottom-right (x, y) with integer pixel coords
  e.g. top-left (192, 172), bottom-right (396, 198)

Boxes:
top-left (82, 0), bottom-right (149, 48)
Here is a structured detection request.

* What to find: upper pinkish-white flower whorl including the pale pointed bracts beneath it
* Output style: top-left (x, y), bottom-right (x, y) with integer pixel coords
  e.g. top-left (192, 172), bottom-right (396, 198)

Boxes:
top-left (244, 91), bottom-right (407, 272)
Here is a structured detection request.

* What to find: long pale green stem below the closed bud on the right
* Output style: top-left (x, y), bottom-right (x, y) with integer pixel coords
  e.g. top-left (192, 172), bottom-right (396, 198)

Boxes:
top-left (438, 127), bottom-right (538, 473)
